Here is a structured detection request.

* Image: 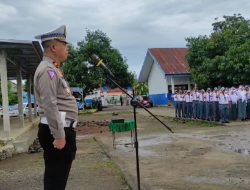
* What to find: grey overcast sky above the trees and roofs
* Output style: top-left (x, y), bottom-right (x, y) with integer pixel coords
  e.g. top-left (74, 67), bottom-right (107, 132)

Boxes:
top-left (0, 0), bottom-right (250, 74)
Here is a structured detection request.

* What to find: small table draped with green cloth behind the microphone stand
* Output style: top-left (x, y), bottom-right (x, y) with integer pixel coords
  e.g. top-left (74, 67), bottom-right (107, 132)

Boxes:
top-left (108, 120), bottom-right (135, 148)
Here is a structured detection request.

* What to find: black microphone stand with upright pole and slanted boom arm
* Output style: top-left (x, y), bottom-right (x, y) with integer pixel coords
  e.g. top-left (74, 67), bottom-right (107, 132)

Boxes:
top-left (102, 73), bottom-right (174, 190)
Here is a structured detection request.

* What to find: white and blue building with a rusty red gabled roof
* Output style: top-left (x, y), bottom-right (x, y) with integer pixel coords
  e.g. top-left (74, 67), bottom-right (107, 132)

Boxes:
top-left (138, 48), bottom-right (194, 105)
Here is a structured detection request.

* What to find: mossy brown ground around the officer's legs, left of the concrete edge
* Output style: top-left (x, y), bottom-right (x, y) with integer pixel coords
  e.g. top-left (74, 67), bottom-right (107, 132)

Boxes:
top-left (0, 116), bottom-right (130, 190)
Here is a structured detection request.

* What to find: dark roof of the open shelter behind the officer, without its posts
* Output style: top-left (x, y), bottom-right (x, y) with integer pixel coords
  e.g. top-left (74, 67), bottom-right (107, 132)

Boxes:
top-left (0, 39), bottom-right (43, 80)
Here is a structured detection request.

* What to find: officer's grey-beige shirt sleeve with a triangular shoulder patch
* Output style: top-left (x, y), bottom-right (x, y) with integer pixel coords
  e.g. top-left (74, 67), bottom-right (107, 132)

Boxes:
top-left (38, 69), bottom-right (65, 138)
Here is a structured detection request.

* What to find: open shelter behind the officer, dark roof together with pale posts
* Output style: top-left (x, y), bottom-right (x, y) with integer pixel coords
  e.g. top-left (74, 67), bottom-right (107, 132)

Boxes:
top-left (0, 39), bottom-right (43, 139)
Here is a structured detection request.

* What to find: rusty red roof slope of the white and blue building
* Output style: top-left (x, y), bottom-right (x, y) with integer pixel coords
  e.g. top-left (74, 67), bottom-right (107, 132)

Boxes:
top-left (149, 48), bottom-right (190, 75)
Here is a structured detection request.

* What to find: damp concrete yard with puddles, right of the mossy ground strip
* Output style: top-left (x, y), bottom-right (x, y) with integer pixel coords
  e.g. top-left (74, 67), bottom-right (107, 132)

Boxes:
top-left (85, 108), bottom-right (250, 190)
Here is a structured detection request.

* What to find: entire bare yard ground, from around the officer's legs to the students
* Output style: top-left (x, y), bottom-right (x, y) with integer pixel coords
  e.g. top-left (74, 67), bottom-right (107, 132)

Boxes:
top-left (0, 106), bottom-right (250, 190)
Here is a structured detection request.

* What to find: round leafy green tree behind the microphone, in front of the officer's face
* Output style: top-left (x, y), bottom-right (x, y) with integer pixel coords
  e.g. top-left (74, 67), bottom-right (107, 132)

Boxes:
top-left (63, 30), bottom-right (134, 93)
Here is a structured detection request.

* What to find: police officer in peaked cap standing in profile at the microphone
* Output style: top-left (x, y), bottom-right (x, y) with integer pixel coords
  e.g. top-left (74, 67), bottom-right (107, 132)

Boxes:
top-left (34, 26), bottom-right (78, 190)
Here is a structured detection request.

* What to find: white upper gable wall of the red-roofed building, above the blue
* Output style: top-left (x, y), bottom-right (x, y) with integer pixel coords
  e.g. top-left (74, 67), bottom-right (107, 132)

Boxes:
top-left (148, 63), bottom-right (168, 95)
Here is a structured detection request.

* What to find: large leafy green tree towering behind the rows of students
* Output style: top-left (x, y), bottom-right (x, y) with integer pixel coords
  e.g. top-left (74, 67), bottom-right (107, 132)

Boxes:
top-left (186, 14), bottom-right (250, 87)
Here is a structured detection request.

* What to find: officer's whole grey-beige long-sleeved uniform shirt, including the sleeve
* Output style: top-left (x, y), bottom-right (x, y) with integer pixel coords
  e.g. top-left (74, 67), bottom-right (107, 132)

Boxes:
top-left (34, 57), bottom-right (78, 138)
